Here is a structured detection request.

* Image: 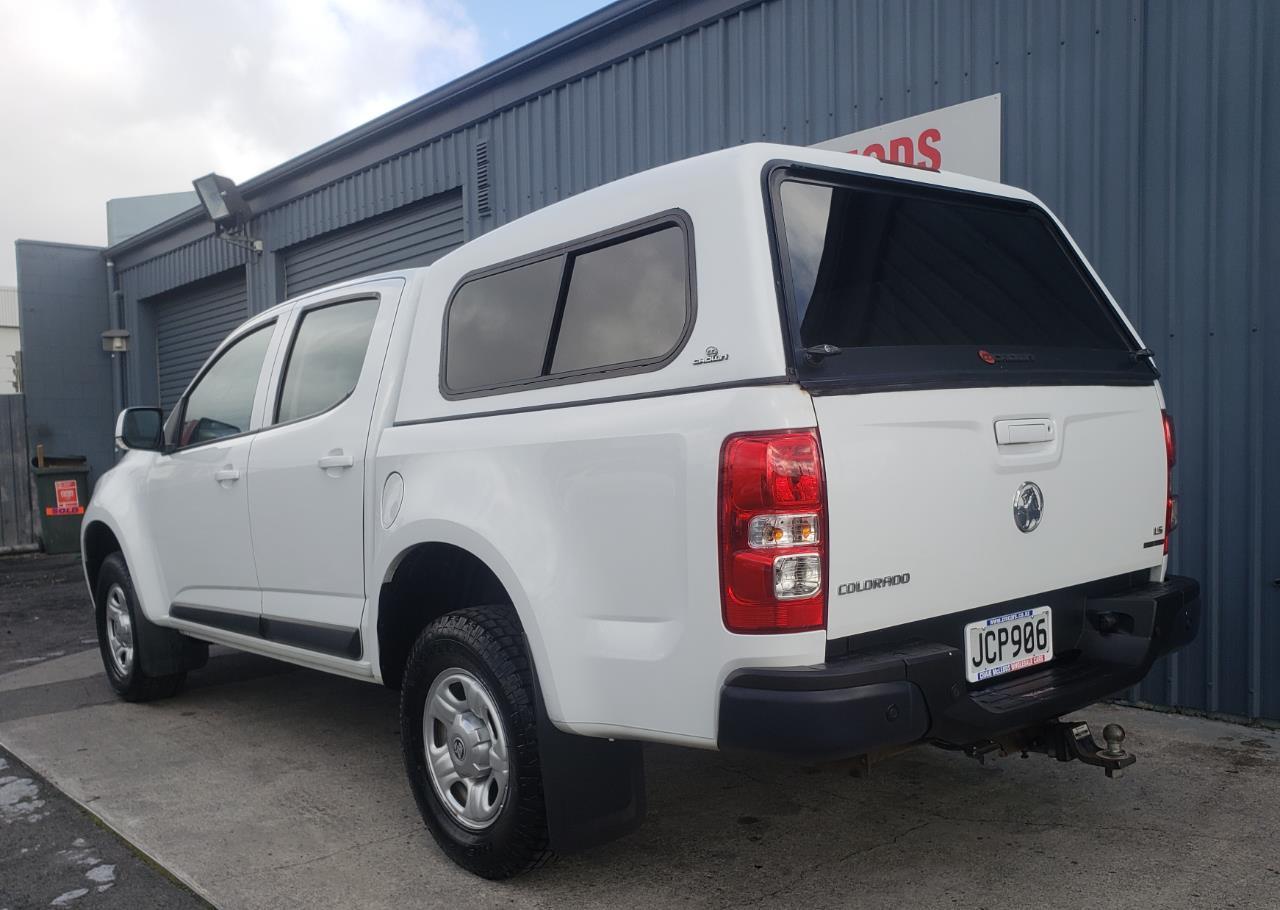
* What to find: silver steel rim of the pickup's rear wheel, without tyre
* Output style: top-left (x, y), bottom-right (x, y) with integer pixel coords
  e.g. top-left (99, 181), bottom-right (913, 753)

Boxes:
top-left (422, 668), bottom-right (511, 831)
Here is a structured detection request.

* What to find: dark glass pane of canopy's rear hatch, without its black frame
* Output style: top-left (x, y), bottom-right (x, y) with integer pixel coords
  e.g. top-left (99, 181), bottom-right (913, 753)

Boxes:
top-left (781, 180), bottom-right (1129, 351)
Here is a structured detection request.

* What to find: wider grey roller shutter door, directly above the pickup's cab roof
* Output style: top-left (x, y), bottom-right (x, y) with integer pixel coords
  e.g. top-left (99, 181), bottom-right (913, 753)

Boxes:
top-left (284, 191), bottom-right (462, 297)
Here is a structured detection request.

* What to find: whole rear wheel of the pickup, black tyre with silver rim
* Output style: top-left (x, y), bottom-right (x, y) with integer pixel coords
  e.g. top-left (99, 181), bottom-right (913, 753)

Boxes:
top-left (401, 607), bottom-right (552, 879)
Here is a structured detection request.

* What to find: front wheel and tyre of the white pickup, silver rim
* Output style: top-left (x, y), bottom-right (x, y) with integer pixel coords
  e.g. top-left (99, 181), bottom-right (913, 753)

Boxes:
top-left (93, 553), bottom-right (187, 701)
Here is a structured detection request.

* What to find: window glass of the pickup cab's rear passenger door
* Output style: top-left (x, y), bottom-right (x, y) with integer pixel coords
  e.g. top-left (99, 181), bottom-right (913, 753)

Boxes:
top-left (275, 298), bottom-right (378, 422)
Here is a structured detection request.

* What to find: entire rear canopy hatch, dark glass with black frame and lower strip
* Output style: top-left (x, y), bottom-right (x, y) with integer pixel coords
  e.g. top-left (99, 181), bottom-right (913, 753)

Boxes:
top-left (768, 168), bottom-right (1157, 390)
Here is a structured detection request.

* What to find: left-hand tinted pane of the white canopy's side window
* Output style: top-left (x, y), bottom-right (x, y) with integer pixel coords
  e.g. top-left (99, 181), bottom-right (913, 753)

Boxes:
top-left (445, 256), bottom-right (564, 390)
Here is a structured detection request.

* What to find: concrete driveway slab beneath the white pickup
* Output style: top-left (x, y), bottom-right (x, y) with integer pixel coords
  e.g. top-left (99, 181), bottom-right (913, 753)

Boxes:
top-left (0, 637), bottom-right (1280, 910)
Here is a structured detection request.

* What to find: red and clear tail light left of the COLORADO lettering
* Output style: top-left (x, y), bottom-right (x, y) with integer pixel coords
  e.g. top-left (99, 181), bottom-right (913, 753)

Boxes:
top-left (719, 430), bottom-right (827, 632)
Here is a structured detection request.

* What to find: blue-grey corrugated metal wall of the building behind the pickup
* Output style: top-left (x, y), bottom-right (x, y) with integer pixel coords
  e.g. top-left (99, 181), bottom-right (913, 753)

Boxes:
top-left (107, 0), bottom-right (1280, 718)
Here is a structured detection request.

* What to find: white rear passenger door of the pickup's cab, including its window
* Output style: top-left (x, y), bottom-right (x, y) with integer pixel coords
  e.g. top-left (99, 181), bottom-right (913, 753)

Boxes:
top-left (240, 279), bottom-right (404, 659)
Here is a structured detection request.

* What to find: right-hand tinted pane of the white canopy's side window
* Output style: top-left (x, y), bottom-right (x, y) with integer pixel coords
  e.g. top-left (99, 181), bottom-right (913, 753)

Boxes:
top-left (552, 225), bottom-right (689, 372)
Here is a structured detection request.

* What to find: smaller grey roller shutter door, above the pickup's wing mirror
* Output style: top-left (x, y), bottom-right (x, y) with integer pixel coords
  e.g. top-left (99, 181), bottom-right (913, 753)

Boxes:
top-left (155, 270), bottom-right (248, 413)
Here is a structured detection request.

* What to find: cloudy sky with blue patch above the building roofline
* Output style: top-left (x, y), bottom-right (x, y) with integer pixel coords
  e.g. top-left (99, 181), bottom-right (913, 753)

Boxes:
top-left (0, 0), bottom-right (605, 285)
